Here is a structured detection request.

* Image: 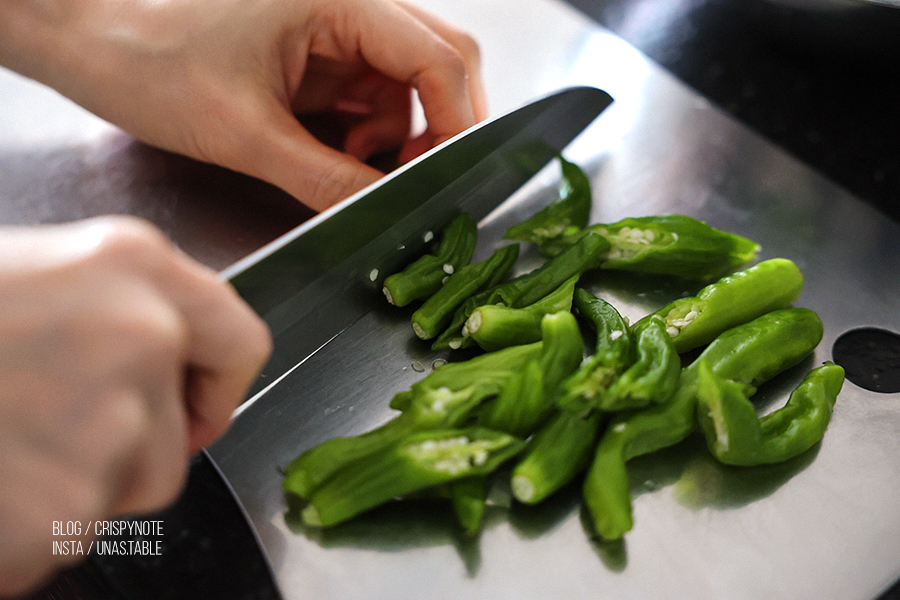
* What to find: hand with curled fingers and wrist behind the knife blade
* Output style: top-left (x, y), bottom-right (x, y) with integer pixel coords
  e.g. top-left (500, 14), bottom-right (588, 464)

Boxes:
top-left (0, 0), bottom-right (487, 210)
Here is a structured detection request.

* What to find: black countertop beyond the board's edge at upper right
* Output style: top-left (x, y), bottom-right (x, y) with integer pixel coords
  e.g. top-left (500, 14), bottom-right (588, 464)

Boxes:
top-left (567, 0), bottom-right (900, 220)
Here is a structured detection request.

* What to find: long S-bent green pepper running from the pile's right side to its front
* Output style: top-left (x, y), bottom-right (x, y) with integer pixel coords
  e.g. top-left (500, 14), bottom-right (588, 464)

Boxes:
top-left (583, 308), bottom-right (822, 539)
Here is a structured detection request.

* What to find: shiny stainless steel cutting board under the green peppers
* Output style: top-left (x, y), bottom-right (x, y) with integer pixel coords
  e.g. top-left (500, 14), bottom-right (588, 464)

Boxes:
top-left (0, 0), bottom-right (900, 600)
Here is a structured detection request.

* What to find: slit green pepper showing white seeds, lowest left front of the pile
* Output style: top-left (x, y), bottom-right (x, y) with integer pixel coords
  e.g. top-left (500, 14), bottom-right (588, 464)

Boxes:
top-left (301, 428), bottom-right (525, 527)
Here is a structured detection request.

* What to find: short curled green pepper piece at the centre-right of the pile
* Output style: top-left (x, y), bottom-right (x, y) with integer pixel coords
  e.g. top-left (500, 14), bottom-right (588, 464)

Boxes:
top-left (598, 317), bottom-right (681, 411)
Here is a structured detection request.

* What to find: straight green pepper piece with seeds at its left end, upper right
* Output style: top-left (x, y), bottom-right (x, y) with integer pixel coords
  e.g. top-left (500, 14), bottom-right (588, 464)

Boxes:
top-left (647, 258), bottom-right (803, 353)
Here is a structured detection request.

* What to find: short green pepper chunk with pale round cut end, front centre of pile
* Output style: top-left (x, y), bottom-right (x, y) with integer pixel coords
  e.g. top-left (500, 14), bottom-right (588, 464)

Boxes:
top-left (510, 410), bottom-right (603, 504)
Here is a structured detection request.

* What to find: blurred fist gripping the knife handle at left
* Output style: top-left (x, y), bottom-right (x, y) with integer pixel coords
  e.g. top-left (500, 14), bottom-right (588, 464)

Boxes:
top-left (0, 217), bottom-right (271, 595)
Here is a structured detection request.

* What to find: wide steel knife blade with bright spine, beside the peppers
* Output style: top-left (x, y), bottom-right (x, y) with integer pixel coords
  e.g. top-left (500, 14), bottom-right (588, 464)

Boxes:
top-left (222, 87), bottom-right (612, 397)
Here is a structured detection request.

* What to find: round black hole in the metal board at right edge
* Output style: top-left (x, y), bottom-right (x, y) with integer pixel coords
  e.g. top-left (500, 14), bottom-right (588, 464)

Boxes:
top-left (831, 327), bottom-right (900, 394)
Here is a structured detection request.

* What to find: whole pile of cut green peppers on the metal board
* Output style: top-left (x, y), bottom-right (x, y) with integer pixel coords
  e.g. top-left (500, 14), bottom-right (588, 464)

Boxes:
top-left (283, 158), bottom-right (844, 540)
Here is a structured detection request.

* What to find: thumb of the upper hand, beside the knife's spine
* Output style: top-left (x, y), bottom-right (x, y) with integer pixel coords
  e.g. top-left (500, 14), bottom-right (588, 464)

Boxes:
top-left (241, 107), bottom-right (384, 212)
